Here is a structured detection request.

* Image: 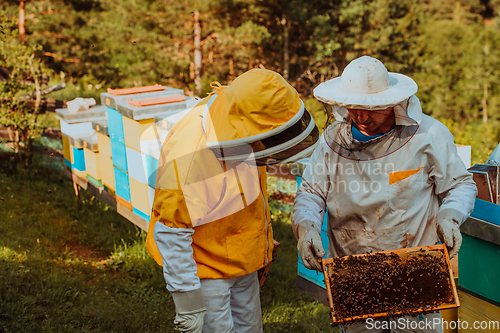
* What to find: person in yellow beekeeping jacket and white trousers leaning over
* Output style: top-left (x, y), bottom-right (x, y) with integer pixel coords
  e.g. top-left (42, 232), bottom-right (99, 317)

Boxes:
top-left (146, 69), bottom-right (319, 333)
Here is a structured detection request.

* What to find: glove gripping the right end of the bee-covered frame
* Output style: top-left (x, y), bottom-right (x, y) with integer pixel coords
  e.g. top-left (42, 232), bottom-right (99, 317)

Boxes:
top-left (437, 208), bottom-right (463, 259)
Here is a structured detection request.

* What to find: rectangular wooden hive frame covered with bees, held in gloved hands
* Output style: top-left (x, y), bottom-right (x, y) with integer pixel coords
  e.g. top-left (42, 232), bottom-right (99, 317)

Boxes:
top-left (321, 245), bottom-right (460, 325)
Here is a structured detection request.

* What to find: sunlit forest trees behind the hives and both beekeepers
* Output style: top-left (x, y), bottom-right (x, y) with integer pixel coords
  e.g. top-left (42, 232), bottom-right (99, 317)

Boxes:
top-left (0, 0), bottom-right (500, 164)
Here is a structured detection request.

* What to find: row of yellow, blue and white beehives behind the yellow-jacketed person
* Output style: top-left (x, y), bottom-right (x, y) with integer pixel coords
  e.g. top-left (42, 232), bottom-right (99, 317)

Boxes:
top-left (56, 85), bottom-right (196, 226)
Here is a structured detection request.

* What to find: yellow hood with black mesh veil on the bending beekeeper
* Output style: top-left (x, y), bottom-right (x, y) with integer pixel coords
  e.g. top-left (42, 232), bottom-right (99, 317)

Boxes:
top-left (203, 69), bottom-right (319, 165)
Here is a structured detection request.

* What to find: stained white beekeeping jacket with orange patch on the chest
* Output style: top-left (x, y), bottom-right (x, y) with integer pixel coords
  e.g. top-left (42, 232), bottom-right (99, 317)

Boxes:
top-left (292, 95), bottom-right (477, 257)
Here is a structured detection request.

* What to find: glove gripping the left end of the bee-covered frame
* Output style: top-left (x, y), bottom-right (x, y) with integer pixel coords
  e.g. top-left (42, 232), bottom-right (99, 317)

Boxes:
top-left (296, 220), bottom-right (325, 271)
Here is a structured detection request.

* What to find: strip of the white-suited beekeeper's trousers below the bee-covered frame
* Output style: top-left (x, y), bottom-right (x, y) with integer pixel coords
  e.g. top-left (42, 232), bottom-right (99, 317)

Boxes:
top-left (340, 312), bottom-right (444, 333)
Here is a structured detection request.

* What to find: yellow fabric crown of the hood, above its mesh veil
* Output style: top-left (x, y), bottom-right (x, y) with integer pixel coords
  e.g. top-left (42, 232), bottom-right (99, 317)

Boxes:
top-left (204, 69), bottom-right (302, 145)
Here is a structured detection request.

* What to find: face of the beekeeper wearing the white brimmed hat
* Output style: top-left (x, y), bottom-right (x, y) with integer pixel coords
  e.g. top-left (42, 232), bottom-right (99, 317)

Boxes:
top-left (347, 107), bottom-right (395, 135)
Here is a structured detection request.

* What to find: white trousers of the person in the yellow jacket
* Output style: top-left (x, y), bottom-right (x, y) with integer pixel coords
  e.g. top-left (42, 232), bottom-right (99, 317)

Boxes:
top-left (200, 272), bottom-right (262, 333)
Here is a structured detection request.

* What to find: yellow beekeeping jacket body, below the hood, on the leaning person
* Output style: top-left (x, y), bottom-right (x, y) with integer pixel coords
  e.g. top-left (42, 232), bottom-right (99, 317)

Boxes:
top-left (146, 95), bottom-right (273, 279)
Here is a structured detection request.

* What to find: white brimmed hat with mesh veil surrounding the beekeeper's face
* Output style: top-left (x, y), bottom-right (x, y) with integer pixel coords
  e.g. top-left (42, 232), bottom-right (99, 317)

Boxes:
top-left (313, 56), bottom-right (422, 161)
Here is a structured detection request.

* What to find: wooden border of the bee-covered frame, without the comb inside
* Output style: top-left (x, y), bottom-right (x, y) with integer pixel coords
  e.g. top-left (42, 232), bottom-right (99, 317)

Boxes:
top-left (320, 244), bottom-right (460, 326)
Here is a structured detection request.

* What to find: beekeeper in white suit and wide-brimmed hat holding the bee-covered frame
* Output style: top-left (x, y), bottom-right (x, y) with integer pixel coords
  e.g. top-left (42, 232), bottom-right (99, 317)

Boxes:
top-left (292, 56), bottom-right (477, 332)
